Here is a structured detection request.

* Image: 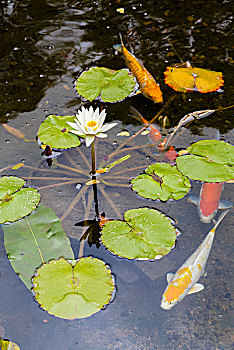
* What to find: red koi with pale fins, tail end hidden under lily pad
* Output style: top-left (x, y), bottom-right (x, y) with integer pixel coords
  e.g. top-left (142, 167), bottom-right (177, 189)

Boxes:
top-left (188, 182), bottom-right (232, 223)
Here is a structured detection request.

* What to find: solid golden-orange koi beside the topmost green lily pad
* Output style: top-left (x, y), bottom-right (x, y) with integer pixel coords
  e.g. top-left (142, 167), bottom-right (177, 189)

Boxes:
top-left (114, 34), bottom-right (163, 103)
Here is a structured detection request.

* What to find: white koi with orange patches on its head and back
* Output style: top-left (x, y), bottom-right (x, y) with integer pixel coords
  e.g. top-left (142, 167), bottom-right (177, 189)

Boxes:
top-left (161, 210), bottom-right (229, 310)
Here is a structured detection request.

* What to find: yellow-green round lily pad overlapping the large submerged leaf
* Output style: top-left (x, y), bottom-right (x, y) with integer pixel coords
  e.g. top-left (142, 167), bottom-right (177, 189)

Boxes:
top-left (33, 257), bottom-right (115, 320)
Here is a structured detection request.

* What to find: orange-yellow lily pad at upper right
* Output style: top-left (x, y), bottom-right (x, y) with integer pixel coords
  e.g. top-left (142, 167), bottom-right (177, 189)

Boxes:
top-left (164, 63), bottom-right (224, 93)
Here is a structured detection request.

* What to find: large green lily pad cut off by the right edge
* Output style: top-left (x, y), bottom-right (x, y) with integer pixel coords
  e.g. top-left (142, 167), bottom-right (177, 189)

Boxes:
top-left (176, 140), bottom-right (234, 182)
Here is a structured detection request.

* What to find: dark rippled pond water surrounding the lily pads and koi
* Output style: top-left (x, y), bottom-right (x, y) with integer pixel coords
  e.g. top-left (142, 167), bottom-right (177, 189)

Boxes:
top-left (0, 0), bottom-right (233, 350)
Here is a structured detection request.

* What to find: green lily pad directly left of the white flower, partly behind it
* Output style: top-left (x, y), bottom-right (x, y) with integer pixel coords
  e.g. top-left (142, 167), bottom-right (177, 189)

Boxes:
top-left (37, 114), bottom-right (80, 149)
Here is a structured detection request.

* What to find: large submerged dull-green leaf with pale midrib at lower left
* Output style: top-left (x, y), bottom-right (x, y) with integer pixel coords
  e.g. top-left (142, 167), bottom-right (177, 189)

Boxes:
top-left (3, 205), bottom-right (74, 289)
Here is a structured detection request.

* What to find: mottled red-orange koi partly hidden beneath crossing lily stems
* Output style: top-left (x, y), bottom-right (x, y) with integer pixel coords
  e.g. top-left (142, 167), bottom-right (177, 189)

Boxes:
top-left (130, 106), bottom-right (178, 161)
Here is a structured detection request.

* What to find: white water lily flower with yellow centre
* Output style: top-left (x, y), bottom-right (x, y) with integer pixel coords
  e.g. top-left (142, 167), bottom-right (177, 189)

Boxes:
top-left (67, 106), bottom-right (117, 147)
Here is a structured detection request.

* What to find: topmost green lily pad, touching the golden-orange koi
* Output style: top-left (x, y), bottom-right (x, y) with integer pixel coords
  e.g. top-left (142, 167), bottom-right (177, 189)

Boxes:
top-left (75, 67), bottom-right (136, 102)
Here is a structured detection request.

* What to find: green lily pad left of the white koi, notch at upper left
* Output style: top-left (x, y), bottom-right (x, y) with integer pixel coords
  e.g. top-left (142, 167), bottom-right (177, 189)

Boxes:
top-left (101, 208), bottom-right (176, 260)
